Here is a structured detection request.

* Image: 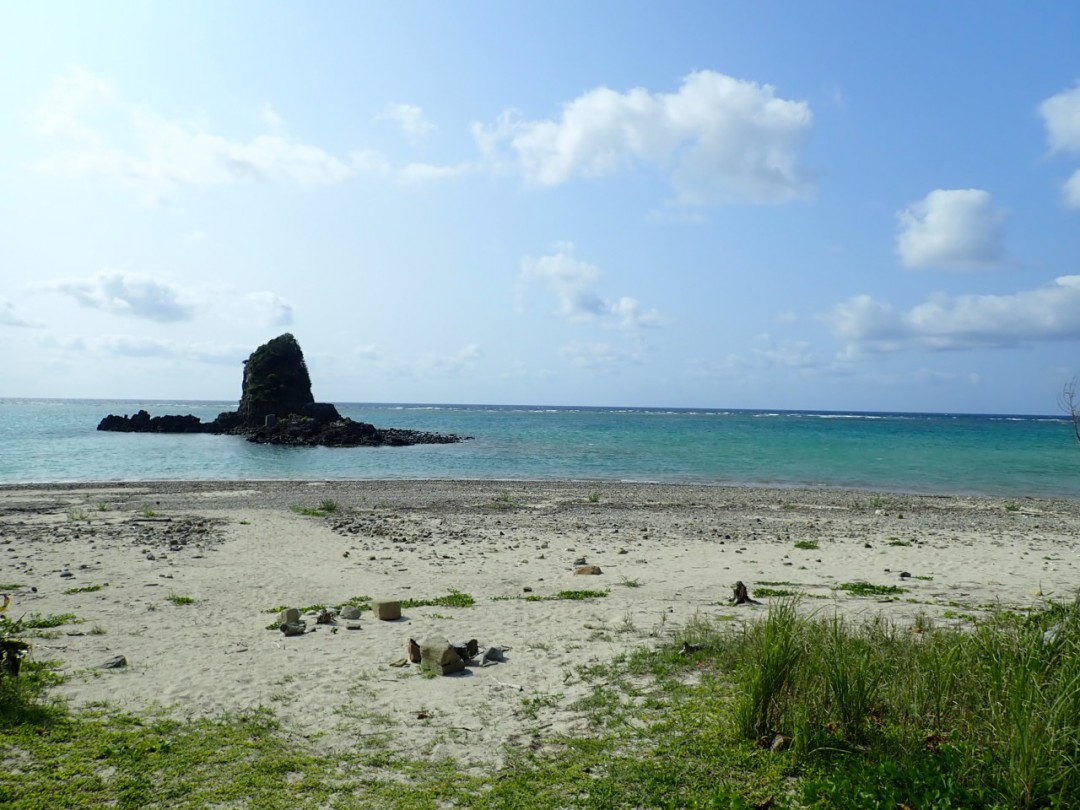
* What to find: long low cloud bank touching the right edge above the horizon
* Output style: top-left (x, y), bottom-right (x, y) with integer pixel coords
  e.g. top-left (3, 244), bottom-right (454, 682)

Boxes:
top-left (824, 275), bottom-right (1080, 353)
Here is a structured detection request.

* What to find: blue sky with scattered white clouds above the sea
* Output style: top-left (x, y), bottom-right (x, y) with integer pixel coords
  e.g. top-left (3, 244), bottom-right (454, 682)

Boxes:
top-left (0, 0), bottom-right (1080, 414)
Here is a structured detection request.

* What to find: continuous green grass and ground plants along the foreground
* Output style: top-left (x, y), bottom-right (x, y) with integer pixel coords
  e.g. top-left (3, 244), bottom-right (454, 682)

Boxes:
top-left (0, 600), bottom-right (1080, 810)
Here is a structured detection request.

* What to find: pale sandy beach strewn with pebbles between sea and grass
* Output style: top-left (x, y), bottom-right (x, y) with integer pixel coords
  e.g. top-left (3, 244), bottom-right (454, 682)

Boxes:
top-left (0, 481), bottom-right (1080, 767)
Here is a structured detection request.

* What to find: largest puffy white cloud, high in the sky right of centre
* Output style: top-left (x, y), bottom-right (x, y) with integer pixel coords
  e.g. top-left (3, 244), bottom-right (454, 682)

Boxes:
top-left (473, 70), bottom-right (812, 204)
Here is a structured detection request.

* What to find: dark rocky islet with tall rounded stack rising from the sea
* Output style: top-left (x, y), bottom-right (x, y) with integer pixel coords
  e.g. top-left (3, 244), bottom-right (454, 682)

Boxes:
top-left (97, 333), bottom-right (465, 447)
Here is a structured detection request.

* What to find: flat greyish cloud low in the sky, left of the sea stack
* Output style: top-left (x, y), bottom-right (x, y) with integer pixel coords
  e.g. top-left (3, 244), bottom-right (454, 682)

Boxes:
top-left (44, 271), bottom-right (194, 323)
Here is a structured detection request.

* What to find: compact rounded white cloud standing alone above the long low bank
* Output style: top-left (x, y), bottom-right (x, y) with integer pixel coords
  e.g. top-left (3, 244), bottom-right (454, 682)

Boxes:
top-left (896, 189), bottom-right (1005, 270)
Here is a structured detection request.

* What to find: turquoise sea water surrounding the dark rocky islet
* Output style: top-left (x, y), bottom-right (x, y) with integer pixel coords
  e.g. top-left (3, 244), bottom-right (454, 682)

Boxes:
top-left (0, 400), bottom-right (1080, 498)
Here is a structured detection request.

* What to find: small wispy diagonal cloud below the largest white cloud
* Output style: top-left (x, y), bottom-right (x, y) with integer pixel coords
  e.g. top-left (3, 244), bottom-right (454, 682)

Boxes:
top-left (522, 243), bottom-right (664, 334)
